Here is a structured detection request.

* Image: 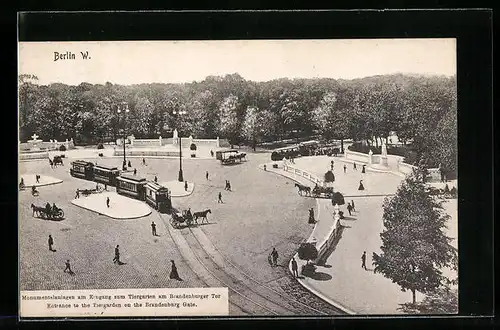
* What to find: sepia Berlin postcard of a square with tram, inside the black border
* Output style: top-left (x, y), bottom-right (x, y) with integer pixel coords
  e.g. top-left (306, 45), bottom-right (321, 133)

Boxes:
top-left (18, 38), bottom-right (459, 317)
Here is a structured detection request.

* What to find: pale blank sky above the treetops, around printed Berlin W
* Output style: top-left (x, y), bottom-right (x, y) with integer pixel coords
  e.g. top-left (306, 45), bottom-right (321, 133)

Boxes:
top-left (18, 39), bottom-right (456, 85)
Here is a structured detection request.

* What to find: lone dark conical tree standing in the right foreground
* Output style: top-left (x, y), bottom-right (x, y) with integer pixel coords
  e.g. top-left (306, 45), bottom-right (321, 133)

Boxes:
top-left (373, 170), bottom-right (456, 303)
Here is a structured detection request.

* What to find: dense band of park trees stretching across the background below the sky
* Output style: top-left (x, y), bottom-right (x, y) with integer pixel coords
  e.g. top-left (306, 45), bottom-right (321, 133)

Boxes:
top-left (19, 73), bottom-right (457, 170)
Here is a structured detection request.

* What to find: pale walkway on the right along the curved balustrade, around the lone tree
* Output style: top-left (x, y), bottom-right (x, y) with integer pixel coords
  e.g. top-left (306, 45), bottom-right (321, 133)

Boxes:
top-left (267, 157), bottom-right (458, 314)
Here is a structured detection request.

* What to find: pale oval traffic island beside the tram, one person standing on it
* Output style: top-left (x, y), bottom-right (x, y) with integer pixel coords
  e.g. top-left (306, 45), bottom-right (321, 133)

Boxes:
top-left (71, 192), bottom-right (151, 219)
